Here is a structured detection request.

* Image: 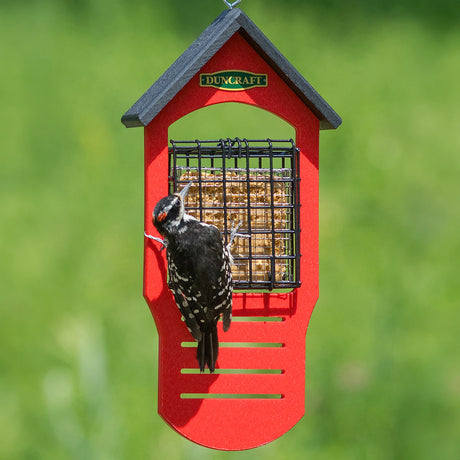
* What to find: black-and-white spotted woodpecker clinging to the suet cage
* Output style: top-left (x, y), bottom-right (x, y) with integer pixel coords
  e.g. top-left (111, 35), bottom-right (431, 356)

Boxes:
top-left (152, 182), bottom-right (233, 372)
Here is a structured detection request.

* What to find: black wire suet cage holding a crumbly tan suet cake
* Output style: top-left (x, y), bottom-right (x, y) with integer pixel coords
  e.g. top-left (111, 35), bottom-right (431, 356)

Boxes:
top-left (169, 138), bottom-right (300, 290)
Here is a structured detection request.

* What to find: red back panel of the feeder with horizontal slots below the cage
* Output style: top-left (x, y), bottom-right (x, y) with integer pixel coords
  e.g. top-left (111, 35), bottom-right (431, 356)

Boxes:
top-left (144, 33), bottom-right (319, 450)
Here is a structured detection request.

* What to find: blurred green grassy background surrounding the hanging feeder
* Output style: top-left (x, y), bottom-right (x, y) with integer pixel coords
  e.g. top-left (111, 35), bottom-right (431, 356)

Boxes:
top-left (0, 0), bottom-right (460, 460)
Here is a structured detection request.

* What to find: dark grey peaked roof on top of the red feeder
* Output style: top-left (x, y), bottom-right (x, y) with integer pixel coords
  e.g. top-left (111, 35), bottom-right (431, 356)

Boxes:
top-left (121, 8), bottom-right (342, 129)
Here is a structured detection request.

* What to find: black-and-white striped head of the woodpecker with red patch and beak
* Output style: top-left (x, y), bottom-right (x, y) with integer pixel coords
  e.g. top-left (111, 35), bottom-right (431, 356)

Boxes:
top-left (152, 182), bottom-right (192, 235)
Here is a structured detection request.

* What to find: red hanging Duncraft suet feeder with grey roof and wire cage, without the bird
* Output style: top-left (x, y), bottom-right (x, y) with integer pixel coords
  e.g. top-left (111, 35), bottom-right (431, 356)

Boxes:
top-left (122, 5), bottom-right (341, 450)
